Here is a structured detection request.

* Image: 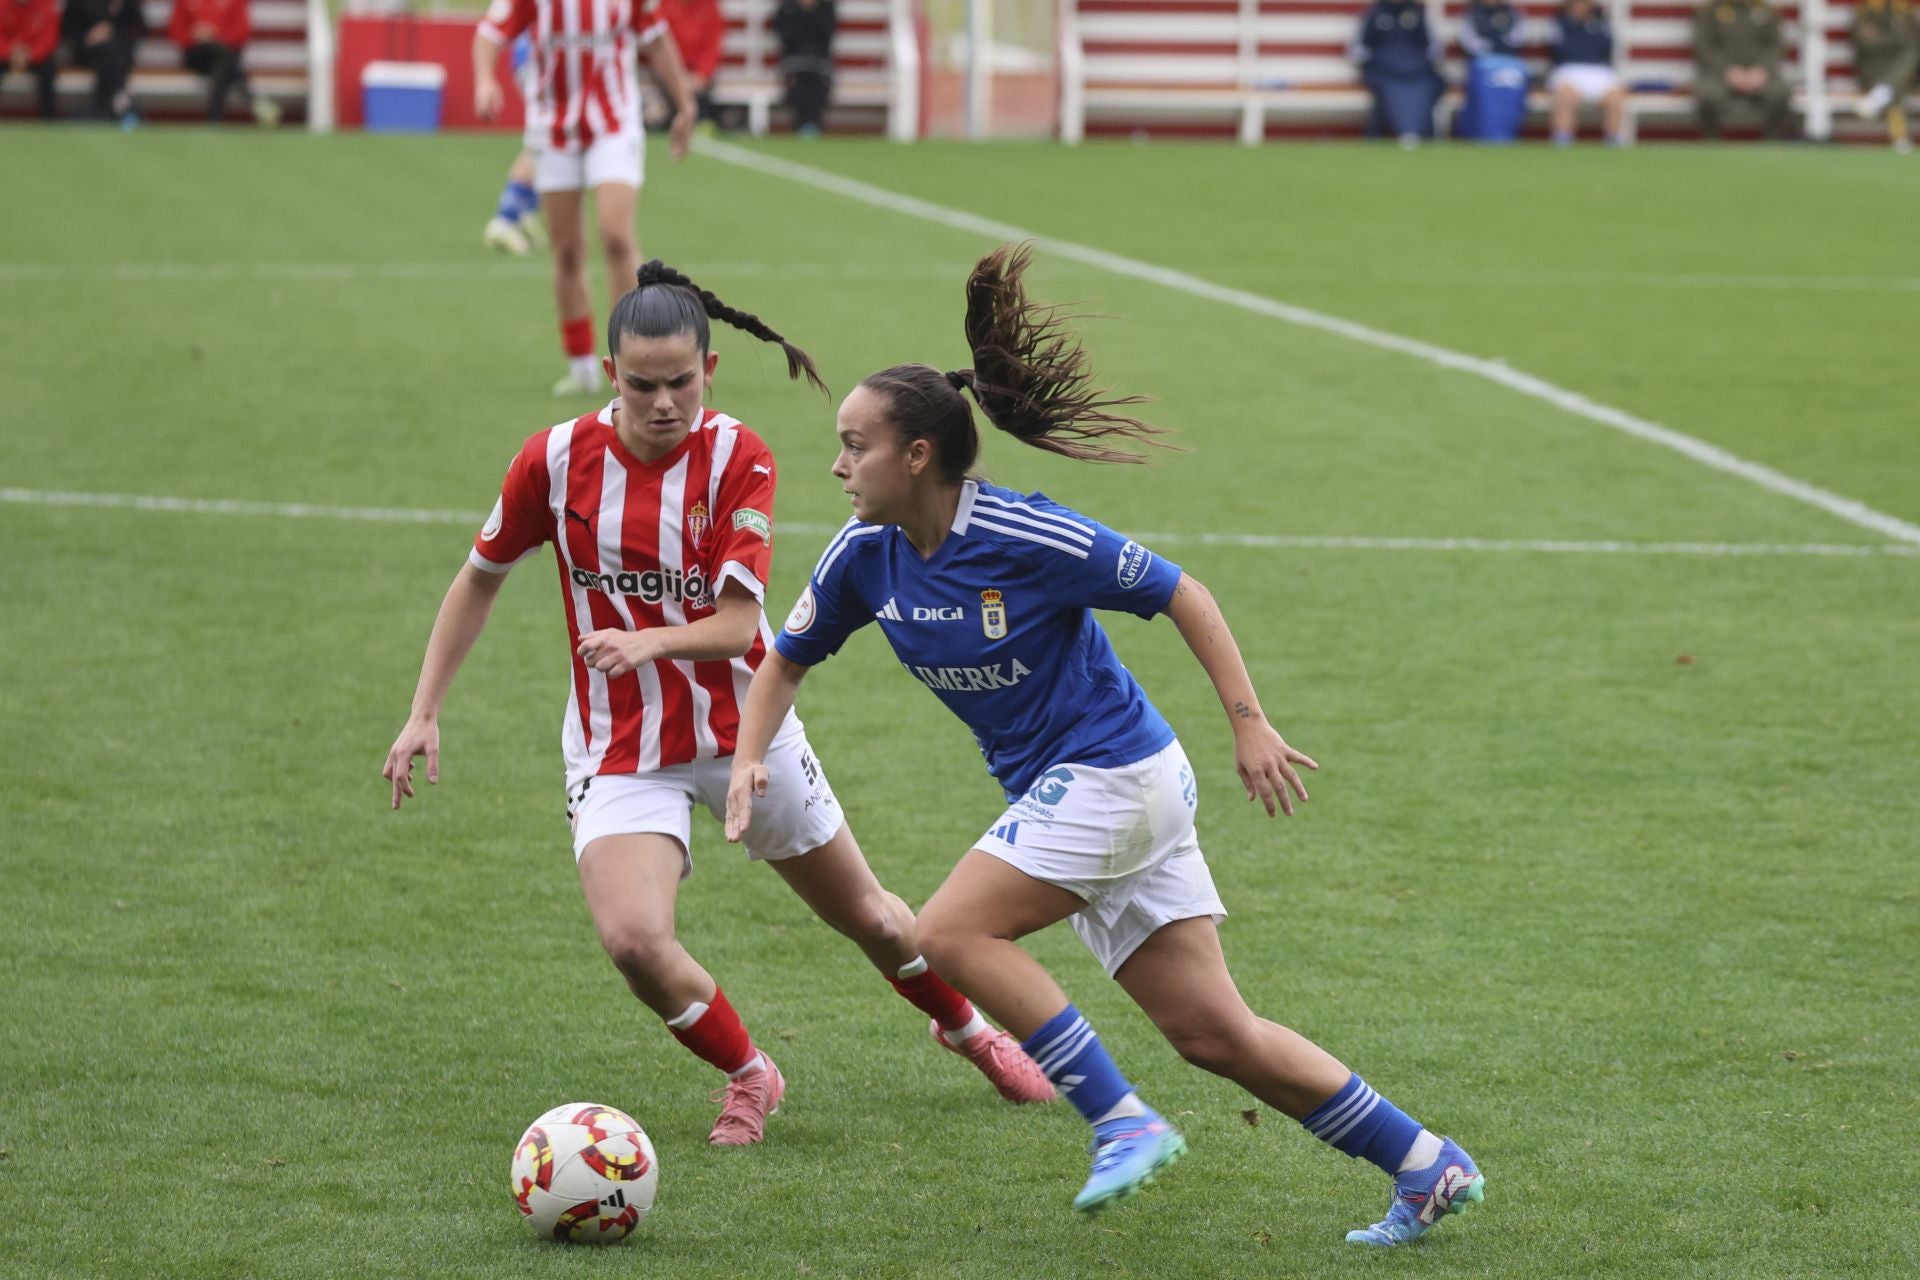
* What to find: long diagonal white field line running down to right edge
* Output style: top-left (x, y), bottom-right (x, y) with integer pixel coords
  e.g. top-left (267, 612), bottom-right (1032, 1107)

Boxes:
top-left (695, 140), bottom-right (1920, 545)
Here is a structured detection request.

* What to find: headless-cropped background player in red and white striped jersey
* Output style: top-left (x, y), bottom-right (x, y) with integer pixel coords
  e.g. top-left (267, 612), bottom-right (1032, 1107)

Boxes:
top-left (472, 0), bottom-right (693, 395)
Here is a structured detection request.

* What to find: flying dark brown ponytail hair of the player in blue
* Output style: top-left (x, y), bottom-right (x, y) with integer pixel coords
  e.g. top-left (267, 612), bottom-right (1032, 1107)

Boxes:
top-left (860, 244), bottom-right (1171, 484)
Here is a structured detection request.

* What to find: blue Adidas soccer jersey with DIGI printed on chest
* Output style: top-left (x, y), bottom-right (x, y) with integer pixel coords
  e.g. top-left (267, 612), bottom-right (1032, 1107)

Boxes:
top-left (774, 482), bottom-right (1181, 800)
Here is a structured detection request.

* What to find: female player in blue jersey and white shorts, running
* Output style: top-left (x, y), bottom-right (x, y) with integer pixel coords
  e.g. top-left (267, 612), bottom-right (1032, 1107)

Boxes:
top-left (728, 248), bottom-right (1484, 1245)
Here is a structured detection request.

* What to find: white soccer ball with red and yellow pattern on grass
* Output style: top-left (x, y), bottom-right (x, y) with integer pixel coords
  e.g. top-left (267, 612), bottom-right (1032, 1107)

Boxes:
top-left (513, 1102), bottom-right (660, 1244)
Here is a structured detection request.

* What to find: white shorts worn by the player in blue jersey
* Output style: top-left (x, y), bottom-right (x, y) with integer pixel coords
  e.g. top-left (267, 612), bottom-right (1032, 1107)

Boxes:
top-left (973, 743), bottom-right (1227, 977)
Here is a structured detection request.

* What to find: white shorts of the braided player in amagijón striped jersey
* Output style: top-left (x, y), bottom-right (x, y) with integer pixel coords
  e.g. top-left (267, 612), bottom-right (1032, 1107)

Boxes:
top-left (566, 712), bottom-right (845, 879)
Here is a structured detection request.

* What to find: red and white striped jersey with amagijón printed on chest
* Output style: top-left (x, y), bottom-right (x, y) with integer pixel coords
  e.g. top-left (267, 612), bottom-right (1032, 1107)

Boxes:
top-left (468, 405), bottom-right (774, 789)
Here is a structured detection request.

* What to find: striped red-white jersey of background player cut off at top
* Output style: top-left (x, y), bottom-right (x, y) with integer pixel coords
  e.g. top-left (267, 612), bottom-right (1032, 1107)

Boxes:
top-left (480, 0), bottom-right (666, 150)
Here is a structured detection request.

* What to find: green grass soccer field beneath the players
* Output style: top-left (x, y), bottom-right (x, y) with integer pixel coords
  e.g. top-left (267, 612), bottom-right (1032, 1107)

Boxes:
top-left (0, 129), bottom-right (1920, 1280)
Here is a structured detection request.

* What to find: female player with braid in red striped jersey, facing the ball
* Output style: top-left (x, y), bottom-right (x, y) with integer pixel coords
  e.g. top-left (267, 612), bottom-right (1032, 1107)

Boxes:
top-left (384, 261), bottom-right (1054, 1146)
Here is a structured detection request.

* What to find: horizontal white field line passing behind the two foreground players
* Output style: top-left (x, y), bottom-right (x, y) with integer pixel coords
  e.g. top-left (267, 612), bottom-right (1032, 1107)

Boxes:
top-left (0, 489), bottom-right (1920, 558)
